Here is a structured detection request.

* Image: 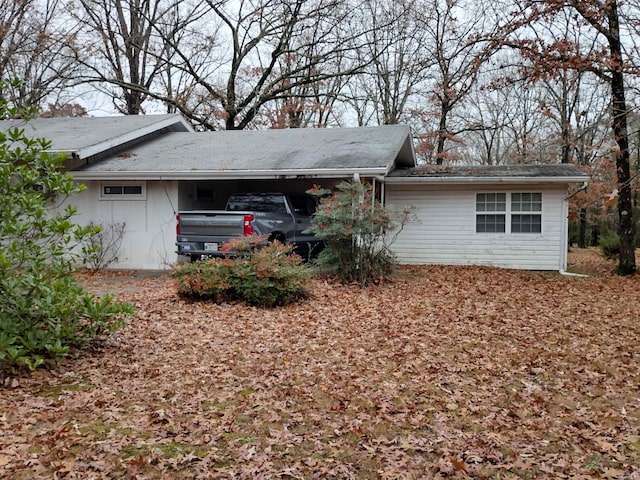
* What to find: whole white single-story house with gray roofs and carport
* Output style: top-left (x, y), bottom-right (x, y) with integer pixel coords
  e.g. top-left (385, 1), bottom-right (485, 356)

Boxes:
top-left (0, 115), bottom-right (588, 270)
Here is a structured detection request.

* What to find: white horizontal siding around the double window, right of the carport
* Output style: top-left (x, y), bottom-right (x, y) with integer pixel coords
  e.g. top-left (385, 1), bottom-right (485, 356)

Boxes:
top-left (386, 185), bottom-right (567, 270)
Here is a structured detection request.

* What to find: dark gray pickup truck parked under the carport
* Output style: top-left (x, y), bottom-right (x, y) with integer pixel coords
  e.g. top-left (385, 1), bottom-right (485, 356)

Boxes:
top-left (176, 193), bottom-right (321, 261)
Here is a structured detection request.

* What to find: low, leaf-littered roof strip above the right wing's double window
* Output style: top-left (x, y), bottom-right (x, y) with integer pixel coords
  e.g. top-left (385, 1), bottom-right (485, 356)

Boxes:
top-left (388, 164), bottom-right (589, 183)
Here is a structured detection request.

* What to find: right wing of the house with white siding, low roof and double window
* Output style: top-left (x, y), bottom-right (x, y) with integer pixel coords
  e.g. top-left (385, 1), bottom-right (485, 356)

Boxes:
top-left (385, 164), bottom-right (589, 271)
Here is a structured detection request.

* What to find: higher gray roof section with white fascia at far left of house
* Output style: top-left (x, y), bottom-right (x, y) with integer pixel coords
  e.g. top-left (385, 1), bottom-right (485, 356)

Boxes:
top-left (0, 114), bottom-right (193, 159)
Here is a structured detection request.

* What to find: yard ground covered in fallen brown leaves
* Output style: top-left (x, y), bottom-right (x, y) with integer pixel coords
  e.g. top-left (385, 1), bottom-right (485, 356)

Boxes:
top-left (0, 252), bottom-right (640, 479)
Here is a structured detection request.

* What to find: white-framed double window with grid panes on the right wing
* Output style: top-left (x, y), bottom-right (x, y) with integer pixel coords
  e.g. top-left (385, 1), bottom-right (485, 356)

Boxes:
top-left (476, 192), bottom-right (542, 233)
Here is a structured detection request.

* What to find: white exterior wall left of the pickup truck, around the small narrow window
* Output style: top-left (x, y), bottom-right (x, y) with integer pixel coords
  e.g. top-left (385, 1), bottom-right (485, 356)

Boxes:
top-left (71, 181), bottom-right (178, 270)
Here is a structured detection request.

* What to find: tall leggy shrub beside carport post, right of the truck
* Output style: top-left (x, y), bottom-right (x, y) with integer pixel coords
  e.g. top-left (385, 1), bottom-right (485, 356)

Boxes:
top-left (308, 182), bottom-right (412, 287)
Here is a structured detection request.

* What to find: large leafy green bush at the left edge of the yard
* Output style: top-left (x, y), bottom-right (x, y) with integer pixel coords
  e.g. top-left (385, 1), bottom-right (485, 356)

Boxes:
top-left (0, 82), bottom-right (132, 382)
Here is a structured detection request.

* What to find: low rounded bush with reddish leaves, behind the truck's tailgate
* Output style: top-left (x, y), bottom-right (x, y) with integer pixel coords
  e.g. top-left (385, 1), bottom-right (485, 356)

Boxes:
top-left (172, 237), bottom-right (309, 308)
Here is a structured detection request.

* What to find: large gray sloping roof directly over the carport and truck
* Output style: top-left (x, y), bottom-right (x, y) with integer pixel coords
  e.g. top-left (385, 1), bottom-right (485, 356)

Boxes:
top-left (71, 125), bottom-right (415, 180)
